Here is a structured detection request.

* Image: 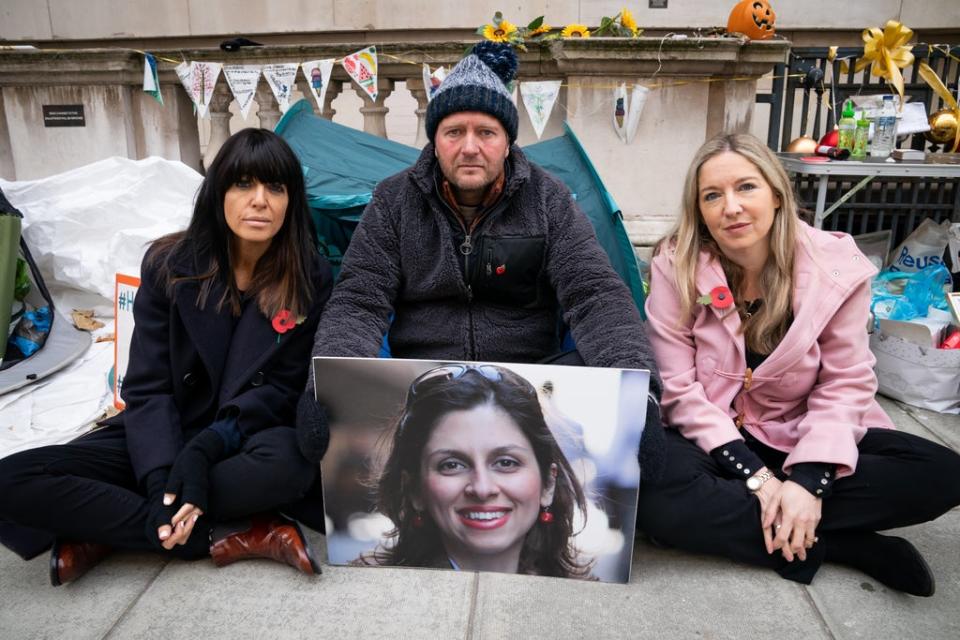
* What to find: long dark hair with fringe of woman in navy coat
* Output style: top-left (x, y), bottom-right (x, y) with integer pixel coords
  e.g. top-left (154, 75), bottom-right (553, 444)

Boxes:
top-left (147, 129), bottom-right (317, 318)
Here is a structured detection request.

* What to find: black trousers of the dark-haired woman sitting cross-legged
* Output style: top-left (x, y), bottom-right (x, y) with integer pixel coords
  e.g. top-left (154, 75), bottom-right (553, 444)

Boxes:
top-left (0, 427), bottom-right (317, 559)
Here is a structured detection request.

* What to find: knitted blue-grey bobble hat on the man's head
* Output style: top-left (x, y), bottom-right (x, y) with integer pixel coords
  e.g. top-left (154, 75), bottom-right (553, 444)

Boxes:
top-left (427, 40), bottom-right (518, 144)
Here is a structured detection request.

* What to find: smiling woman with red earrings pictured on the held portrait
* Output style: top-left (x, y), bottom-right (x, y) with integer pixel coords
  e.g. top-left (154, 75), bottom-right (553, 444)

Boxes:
top-left (356, 365), bottom-right (591, 578)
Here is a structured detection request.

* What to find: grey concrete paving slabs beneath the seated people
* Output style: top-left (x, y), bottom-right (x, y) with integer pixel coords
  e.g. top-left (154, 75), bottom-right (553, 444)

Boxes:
top-left (0, 398), bottom-right (960, 640)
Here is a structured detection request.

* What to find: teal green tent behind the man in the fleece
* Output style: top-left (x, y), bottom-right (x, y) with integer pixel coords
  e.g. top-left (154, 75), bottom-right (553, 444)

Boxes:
top-left (276, 100), bottom-right (644, 316)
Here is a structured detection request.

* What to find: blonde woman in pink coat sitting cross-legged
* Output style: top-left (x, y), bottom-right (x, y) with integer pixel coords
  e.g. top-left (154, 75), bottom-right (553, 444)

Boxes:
top-left (638, 135), bottom-right (960, 596)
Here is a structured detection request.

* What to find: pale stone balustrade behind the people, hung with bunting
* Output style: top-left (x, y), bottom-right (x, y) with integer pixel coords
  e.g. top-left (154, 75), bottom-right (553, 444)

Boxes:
top-left (0, 38), bottom-right (790, 244)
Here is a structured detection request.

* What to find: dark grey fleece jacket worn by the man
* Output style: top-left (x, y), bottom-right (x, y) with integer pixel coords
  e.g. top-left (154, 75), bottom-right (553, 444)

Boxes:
top-left (298, 144), bottom-right (660, 480)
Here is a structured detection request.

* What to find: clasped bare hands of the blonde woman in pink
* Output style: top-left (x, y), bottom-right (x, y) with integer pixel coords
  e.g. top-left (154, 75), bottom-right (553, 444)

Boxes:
top-left (755, 470), bottom-right (823, 562)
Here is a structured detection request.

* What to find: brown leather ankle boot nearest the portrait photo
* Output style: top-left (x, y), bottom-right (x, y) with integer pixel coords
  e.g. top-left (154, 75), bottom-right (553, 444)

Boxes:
top-left (210, 514), bottom-right (320, 576)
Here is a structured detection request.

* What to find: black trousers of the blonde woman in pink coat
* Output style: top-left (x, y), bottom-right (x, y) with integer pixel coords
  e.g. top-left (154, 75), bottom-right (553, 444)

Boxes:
top-left (637, 429), bottom-right (960, 584)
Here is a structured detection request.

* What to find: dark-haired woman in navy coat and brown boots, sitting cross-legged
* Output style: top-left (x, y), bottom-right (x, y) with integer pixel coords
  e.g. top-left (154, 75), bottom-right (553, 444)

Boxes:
top-left (0, 129), bottom-right (331, 585)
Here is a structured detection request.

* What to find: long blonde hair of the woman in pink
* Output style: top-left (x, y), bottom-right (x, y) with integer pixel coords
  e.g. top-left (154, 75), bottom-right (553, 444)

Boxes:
top-left (657, 134), bottom-right (801, 354)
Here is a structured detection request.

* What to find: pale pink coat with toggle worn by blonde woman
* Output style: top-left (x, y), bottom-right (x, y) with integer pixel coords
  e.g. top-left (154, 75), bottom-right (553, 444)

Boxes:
top-left (646, 224), bottom-right (893, 477)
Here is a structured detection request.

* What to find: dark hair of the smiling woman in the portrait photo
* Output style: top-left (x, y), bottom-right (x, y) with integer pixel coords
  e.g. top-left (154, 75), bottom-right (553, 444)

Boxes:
top-left (355, 365), bottom-right (593, 579)
